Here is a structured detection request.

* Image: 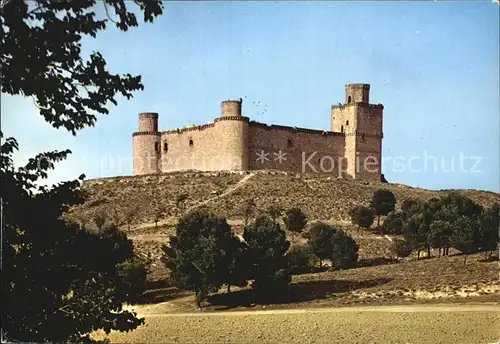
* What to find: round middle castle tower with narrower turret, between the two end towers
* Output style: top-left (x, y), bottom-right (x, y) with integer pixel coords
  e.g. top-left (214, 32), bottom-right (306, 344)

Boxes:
top-left (215, 98), bottom-right (249, 171)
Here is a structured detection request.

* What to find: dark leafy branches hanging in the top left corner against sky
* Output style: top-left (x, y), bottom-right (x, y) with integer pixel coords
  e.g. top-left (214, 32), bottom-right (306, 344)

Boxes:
top-left (0, 0), bottom-right (163, 135)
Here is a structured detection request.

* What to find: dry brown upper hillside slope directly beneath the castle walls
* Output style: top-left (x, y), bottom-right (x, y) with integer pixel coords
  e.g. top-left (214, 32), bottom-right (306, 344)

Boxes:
top-left (69, 171), bottom-right (500, 225)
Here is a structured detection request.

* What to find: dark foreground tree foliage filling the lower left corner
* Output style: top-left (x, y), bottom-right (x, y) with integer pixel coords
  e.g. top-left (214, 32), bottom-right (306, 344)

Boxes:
top-left (0, 139), bottom-right (148, 342)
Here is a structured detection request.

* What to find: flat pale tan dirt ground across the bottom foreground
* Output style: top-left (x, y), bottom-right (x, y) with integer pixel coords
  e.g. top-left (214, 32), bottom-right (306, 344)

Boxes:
top-left (94, 305), bottom-right (500, 344)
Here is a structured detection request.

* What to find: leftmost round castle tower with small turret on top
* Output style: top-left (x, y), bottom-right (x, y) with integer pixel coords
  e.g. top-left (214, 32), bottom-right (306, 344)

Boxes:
top-left (132, 112), bottom-right (161, 176)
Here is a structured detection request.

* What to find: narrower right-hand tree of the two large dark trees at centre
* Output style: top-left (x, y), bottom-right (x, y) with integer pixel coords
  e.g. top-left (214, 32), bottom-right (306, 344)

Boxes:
top-left (243, 216), bottom-right (291, 298)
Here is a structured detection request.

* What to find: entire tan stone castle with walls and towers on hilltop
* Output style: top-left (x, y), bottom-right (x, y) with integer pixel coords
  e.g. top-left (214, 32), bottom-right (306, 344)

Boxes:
top-left (132, 84), bottom-right (384, 181)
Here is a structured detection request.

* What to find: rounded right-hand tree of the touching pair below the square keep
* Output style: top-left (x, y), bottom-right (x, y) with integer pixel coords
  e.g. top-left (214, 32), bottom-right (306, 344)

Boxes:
top-left (330, 229), bottom-right (359, 269)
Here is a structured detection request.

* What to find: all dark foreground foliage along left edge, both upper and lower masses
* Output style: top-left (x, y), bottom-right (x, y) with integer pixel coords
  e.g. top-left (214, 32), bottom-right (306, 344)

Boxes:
top-left (0, 0), bottom-right (163, 342)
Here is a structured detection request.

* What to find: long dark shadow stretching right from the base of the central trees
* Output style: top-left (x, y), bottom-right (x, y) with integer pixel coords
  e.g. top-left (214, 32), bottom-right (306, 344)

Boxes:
top-left (207, 278), bottom-right (392, 310)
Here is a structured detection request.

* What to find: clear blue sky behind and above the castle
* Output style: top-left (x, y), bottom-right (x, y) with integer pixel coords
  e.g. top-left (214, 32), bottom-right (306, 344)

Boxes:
top-left (1, 1), bottom-right (500, 192)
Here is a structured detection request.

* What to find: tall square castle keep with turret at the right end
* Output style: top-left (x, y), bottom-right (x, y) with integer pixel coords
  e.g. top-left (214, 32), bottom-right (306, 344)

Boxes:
top-left (332, 84), bottom-right (384, 181)
